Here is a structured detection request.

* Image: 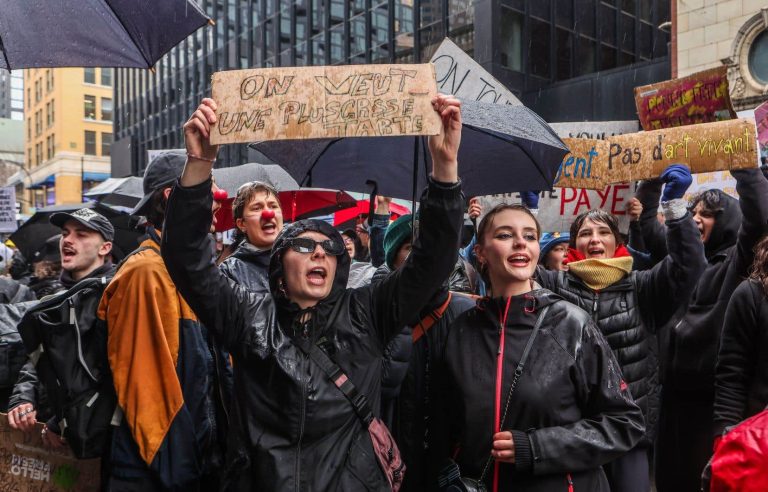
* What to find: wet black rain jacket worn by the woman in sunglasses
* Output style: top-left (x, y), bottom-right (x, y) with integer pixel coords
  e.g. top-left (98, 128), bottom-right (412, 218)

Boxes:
top-left (162, 181), bottom-right (463, 492)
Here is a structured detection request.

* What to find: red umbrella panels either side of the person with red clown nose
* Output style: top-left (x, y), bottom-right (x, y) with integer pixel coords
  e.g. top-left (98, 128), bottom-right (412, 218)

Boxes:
top-left (216, 188), bottom-right (356, 231)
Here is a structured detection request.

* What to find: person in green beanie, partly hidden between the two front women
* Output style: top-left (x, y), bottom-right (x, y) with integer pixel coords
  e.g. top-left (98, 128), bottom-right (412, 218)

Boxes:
top-left (371, 214), bottom-right (475, 491)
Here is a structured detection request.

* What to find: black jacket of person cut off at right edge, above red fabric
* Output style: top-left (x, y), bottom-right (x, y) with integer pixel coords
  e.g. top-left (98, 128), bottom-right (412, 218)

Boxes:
top-left (714, 280), bottom-right (768, 436)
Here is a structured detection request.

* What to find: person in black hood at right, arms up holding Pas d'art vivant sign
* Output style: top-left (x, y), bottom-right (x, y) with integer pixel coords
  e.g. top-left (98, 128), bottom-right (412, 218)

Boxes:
top-left (638, 168), bottom-right (768, 492)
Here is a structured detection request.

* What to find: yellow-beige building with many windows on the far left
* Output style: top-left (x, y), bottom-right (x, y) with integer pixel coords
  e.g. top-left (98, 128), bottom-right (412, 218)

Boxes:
top-left (11, 68), bottom-right (113, 211)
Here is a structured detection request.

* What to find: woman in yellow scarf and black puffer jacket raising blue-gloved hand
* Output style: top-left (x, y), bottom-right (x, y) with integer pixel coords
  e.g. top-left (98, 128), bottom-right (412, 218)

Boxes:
top-left (538, 166), bottom-right (704, 492)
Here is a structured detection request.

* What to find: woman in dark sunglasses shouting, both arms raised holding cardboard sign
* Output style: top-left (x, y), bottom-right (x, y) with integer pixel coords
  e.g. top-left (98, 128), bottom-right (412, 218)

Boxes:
top-left (163, 95), bottom-right (463, 492)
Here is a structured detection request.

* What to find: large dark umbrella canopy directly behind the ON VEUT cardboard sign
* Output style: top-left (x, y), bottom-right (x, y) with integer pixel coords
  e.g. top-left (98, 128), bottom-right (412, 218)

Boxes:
top-left (251, 101), bottom-right (568, 199)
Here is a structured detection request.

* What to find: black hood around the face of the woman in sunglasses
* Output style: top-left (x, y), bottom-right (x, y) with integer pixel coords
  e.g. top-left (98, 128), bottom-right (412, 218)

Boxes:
top-left (269, 219), bottom-right (350, 298)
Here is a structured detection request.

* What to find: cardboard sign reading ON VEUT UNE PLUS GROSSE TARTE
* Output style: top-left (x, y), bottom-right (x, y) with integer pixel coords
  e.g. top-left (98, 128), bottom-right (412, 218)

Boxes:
top-left (211, 63), bottom-right (441, 144)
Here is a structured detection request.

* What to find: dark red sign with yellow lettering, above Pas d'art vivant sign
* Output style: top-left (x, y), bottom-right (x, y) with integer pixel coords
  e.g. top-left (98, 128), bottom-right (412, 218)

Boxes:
top-left (635, 66), bottom-right (736, 130)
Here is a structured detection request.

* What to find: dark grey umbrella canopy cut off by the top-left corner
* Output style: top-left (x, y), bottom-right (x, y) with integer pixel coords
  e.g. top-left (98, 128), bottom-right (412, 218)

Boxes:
top-left (0, 0), bottom-right (211, 70)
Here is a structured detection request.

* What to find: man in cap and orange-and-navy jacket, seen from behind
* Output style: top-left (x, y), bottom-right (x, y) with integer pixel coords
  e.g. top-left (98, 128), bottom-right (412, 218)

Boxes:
top-left (98, 152), bottom-right (226, 492)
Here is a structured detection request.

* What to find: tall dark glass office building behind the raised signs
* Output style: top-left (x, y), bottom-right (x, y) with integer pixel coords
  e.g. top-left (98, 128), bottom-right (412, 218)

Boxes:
top-left (113, 0), bottom-right (669, 175)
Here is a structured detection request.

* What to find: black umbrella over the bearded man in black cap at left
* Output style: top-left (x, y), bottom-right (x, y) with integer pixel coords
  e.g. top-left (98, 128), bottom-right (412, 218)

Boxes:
top-left (10, 202), bottom-right (141, 261)
